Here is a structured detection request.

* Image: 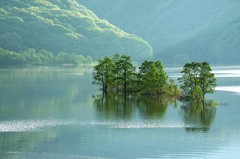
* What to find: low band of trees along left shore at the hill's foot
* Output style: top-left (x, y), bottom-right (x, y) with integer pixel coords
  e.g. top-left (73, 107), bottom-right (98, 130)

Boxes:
top-left (0, 48), bottom-right (93, 66)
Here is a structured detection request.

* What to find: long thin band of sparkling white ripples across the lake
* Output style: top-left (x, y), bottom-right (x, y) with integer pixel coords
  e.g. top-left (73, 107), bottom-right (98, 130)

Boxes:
top-left (0, 120), bottom-right (206, 132)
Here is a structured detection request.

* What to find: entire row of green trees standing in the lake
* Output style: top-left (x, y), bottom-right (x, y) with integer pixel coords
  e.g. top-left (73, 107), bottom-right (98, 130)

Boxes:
top-left (93, 54), bottom-right (216, 101)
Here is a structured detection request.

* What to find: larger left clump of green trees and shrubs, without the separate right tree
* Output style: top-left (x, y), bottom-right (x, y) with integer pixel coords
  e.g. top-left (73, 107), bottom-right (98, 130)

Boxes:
top-left (93, 54), bottom-right (179, 96)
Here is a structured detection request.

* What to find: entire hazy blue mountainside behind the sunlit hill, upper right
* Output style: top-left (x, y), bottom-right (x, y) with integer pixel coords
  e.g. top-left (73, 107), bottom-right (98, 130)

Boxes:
top-left (77, 0), bottom-right (240, 64)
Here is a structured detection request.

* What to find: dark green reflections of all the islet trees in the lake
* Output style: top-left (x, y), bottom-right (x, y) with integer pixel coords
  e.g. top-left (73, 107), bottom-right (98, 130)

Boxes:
top-left (93, 95), bottom-right (216, 132)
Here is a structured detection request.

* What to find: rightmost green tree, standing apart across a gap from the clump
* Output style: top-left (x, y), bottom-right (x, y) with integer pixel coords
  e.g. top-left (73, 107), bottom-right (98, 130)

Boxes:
top-left (178, 62), bottom-right (216, 99)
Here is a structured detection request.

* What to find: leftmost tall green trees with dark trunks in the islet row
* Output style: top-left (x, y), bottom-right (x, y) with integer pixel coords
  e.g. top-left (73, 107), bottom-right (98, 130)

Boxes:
top-left (93, 54), bottom-right (136, 94)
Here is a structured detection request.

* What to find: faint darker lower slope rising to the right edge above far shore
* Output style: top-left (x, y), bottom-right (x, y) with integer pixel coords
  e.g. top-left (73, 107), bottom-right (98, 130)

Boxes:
top-left (163, 19), bottom-right (240, 65)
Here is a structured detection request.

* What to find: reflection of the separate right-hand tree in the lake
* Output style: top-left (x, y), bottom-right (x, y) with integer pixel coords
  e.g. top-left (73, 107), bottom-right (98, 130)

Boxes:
top-left (181, 101), bottom-right (216, 132)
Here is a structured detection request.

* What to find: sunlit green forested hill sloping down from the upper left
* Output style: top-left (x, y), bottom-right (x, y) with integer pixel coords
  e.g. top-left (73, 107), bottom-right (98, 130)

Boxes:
top-left (0, 0), bottom-right (152, 60)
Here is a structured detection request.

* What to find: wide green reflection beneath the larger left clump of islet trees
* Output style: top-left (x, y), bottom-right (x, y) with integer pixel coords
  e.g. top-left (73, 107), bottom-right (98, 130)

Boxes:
top-left (94, 95), bottom-right (174, 119)
